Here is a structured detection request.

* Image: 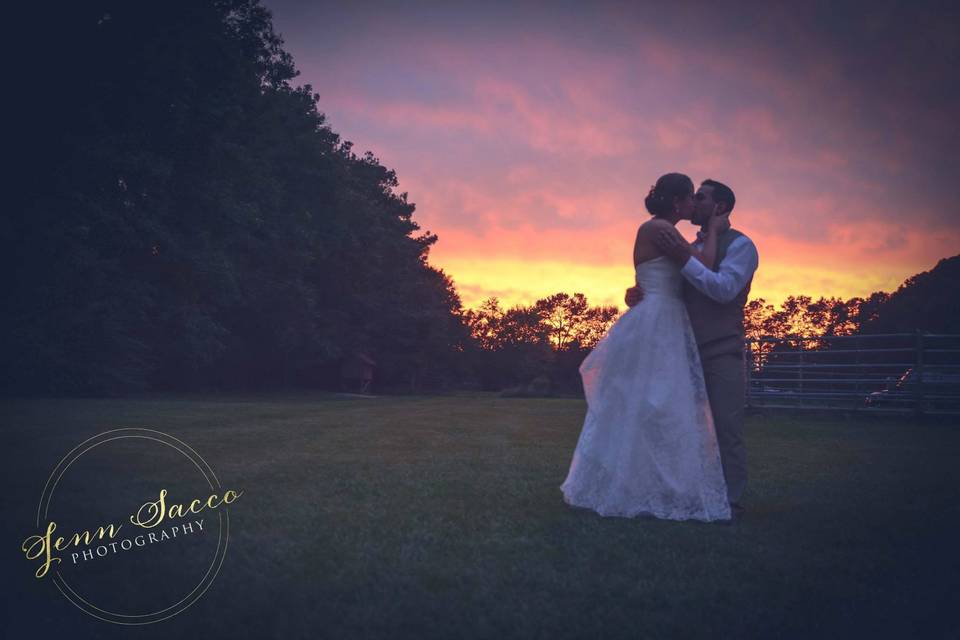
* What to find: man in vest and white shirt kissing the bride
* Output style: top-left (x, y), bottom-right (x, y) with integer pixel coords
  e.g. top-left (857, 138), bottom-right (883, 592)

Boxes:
top-left (624, 180), bottom-right (759, 517)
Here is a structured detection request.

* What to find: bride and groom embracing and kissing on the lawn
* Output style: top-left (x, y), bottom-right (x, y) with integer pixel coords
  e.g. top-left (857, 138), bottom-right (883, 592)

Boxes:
top-left (560, 173), bottom-right (759, 522)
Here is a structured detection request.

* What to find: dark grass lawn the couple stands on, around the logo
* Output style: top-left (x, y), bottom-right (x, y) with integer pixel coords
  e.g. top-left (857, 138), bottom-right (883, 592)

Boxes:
top-left (0, 393), bottom-right (960, 639)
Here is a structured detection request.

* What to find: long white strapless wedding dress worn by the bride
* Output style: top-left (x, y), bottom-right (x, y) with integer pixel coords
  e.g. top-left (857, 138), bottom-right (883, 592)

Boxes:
top-left (560, 256), bottom-right (731, 521)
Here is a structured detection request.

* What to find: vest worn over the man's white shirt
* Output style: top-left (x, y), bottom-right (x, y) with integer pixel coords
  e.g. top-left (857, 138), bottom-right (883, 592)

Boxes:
top-left (683, 229), bottom-right (753, 358)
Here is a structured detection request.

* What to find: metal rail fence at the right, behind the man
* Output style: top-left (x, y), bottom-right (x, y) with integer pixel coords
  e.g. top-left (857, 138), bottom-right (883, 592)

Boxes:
top-left (744, 333), bottom-right (960, 415)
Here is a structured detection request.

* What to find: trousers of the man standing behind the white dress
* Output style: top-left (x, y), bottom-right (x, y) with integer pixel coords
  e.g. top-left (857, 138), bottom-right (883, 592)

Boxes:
top-left (700, 349), bottom-right (747, 505)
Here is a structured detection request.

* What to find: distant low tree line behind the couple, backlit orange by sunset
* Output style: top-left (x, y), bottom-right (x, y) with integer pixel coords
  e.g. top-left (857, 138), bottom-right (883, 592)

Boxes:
top-left (464, 256), bottom-right (960, 394)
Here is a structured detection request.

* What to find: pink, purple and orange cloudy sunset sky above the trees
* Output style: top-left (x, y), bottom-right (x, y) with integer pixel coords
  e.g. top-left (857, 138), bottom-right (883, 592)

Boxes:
top-left (264, 0), bottom-right (960, 308)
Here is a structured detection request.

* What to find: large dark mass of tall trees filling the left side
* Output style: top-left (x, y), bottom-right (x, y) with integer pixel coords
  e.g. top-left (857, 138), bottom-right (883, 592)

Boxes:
top-left (0, 0), bottom-right (469, 394)
